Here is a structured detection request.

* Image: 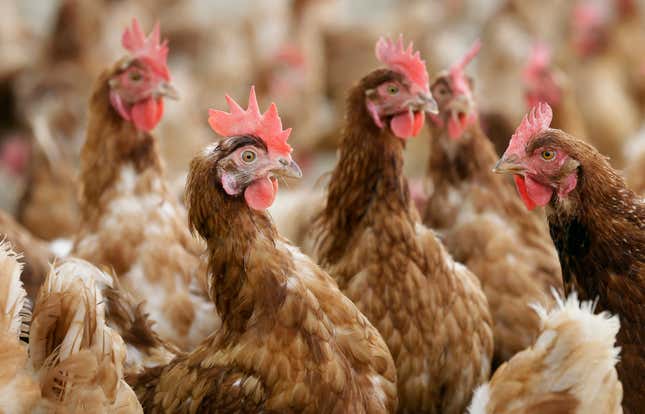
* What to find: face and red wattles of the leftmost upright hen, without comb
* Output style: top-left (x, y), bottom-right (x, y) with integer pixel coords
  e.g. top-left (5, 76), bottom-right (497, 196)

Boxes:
top-left (109, 59), bottom-right (177, 132)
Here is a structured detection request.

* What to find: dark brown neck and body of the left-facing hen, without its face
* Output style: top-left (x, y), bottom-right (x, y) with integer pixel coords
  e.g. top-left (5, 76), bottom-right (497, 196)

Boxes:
top-left (547, 137), bottom-right (645, 413)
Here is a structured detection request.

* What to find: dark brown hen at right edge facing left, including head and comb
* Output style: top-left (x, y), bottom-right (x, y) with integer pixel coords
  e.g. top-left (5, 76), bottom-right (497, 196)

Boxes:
top-left (495, 104), bottom-right (645, 413)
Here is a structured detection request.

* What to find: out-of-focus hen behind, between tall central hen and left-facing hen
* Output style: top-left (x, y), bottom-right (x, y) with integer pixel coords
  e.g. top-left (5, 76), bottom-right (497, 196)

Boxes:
top-left (423, 42), bottom-right (562, 364)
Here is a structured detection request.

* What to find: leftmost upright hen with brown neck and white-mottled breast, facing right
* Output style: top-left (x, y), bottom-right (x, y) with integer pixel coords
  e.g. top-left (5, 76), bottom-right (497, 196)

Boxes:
top-left (73, 20), bottom-right (219, 349)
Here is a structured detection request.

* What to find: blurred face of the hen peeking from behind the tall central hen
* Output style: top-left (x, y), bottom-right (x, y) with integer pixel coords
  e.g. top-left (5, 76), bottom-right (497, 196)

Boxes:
top-left (430, 76), bottom-right (477, 139)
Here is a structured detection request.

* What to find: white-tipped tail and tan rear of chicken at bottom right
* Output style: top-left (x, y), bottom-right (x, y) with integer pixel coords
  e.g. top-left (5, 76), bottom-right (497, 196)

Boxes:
top-left (469, 293), bottom-right (623, 414)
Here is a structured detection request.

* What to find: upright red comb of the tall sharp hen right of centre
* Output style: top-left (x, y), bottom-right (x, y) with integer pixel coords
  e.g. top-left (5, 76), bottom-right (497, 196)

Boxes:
top-left (375, 35), bottom-right (430, 91)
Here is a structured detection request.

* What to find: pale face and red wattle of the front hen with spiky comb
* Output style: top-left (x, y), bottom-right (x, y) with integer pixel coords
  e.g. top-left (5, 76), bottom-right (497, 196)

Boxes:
top-left (217, 136), bottom-right (302, 210)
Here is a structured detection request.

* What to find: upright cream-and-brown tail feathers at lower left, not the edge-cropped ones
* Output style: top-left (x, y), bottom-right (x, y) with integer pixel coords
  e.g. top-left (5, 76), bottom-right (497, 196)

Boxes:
top-left (29, 259), bottom-right (140, 412)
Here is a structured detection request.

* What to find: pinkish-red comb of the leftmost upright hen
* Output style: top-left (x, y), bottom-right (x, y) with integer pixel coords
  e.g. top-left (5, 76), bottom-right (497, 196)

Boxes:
top-left (121, 18), bottom-right (170, 79)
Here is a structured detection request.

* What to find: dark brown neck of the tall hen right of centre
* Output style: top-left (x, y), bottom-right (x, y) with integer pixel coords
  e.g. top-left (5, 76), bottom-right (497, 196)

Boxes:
top-left (319, 85), bottom-right (412, 263)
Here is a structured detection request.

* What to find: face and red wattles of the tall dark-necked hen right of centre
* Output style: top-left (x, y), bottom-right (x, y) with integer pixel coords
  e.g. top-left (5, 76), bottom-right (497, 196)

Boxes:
top-left (365, 72), bottom-right (437, 139)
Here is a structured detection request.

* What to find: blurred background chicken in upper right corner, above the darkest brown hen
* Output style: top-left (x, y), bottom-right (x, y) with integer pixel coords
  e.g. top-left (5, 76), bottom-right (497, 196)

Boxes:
top-left (571, 0), bottom-right (639, 168)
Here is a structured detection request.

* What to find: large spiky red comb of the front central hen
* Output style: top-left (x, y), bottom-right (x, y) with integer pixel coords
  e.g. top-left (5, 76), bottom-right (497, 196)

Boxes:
top-left (208, 86), bottom-right (291, 155)
